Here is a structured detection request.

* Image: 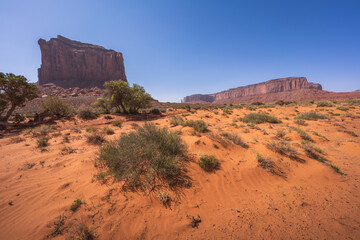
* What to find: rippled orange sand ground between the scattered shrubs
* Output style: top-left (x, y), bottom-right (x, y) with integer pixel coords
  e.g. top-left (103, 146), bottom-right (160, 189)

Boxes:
top-left (0, 106), bottom-right (360, 239)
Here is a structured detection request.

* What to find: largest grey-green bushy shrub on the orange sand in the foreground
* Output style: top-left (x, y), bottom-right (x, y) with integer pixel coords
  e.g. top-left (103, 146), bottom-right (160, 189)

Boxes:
top-left (97, 123), bottom-right (190, 191)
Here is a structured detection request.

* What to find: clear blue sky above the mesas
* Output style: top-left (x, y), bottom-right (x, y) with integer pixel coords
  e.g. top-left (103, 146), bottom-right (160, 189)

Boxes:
top-left (0, 0), bottom-right (360, 102)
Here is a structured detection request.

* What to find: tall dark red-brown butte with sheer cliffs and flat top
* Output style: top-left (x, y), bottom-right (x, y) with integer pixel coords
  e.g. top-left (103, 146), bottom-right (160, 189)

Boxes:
top-left (38, 35), bottom-right (127, 88)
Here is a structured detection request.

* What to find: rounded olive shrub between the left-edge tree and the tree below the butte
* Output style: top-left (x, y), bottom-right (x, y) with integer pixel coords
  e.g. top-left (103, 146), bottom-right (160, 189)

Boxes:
top-left (42, 96), bottom-right (74, 118)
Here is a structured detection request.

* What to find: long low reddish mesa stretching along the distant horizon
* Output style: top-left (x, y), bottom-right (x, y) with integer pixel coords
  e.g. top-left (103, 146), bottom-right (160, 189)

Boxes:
top-left (183, 77), bottom-right (322, 103)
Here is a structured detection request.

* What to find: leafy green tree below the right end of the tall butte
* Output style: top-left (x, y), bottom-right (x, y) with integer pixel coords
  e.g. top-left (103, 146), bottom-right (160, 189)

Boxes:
top-left (104, 80), bottom-right (152, 113)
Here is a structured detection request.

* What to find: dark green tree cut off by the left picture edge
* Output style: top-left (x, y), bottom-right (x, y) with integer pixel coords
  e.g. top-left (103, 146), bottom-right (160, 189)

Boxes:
top-left (0, 72), bottom-right (40, 122)
